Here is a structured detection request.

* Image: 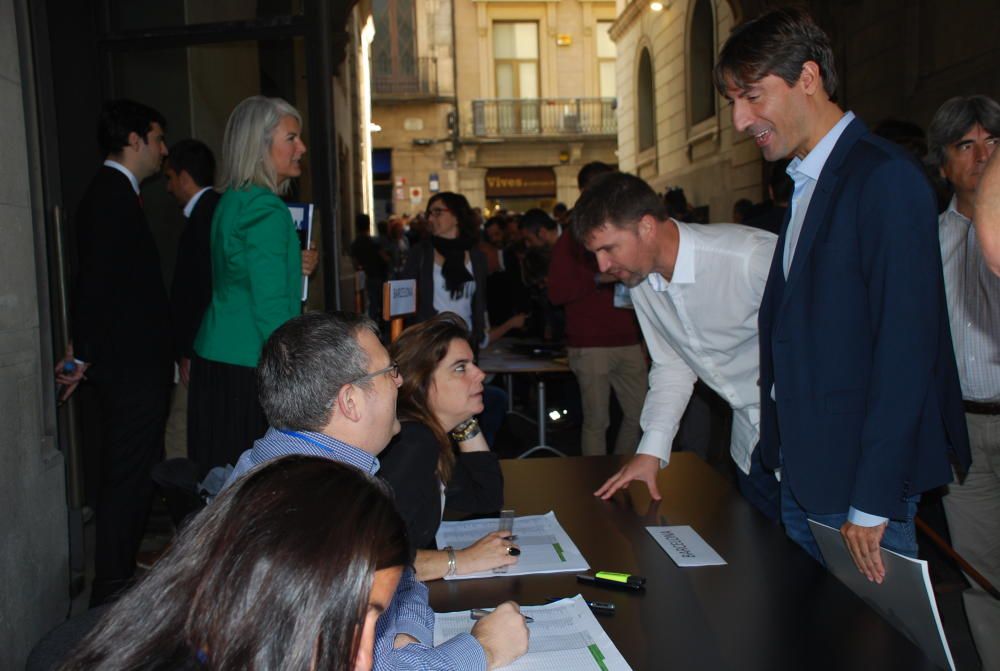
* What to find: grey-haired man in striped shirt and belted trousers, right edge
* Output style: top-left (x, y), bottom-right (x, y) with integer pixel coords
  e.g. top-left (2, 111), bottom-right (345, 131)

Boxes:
top-left (927, 95), bottom-right (1000, 669)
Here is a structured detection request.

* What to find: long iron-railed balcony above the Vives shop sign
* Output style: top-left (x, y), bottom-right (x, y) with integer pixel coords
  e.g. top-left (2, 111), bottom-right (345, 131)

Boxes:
top-left (471, 98), bottom-right (618, 138)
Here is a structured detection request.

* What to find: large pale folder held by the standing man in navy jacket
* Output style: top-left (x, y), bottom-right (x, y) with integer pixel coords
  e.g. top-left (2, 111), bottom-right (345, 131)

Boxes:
top-left (809, 520), bottom-right (955, 671)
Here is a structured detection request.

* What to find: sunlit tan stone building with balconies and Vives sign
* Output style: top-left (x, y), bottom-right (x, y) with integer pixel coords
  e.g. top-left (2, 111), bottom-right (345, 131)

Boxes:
top-left (372, 0), bottom-right (618, 213)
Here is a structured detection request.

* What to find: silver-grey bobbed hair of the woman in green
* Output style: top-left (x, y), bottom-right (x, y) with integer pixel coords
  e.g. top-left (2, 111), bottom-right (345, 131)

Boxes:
top-left (219, 96), bottom-right (302, 193)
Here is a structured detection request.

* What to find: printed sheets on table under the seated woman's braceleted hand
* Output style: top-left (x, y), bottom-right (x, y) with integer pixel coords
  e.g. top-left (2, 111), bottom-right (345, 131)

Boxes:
top-left (435, 510), bottom-right (590, 580)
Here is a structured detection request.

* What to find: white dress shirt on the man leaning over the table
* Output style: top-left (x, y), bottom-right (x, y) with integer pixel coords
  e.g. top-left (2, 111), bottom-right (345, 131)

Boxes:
top-left (631, 222), bottom-right (777, 473)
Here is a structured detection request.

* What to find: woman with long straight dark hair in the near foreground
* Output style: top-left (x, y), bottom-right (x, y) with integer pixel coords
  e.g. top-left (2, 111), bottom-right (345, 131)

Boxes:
top-left (62, 456), bottom-right (409, 671)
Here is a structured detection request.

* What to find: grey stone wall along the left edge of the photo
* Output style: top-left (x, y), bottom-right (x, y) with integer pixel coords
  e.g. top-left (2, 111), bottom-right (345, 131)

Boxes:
top-left (0, 0), bottom-right (69, 669)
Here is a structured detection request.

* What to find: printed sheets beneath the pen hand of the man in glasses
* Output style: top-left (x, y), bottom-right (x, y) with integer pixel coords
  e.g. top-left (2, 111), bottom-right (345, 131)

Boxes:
top-left (434, 594), bottom-right (632, 671)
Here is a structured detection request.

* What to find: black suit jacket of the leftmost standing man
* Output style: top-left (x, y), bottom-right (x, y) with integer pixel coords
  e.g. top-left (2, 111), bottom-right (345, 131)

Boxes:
top-left (71, 166), bottom-right (173, 383)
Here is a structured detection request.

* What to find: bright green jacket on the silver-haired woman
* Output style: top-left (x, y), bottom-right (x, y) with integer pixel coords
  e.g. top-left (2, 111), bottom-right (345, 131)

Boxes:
top-left (194, 186), bottom-right (302, 367)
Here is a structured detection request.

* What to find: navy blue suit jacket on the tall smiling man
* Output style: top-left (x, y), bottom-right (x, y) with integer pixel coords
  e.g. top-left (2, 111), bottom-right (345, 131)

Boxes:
top-left (759, 120), bottom-right (969, 518)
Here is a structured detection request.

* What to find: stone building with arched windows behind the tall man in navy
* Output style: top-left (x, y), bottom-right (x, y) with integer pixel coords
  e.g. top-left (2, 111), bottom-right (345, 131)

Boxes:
top-left (611, 0), bottom-right (1000, 221)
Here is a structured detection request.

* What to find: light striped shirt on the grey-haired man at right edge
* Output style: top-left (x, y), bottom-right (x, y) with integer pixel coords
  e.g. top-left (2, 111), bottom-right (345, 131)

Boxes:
top-left (938, 198), bottom-right (1000, 403)
